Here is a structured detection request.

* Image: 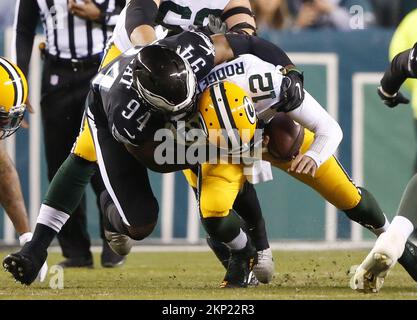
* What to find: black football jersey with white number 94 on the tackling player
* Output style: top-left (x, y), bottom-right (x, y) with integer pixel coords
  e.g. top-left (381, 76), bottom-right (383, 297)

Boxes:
top-left (89, 31), bottom-right (214, 146)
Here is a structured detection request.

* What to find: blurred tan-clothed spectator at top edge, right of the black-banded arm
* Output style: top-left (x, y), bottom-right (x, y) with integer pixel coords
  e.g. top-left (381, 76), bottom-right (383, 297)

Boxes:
top-left (252, 0), bottom-right (289, 29)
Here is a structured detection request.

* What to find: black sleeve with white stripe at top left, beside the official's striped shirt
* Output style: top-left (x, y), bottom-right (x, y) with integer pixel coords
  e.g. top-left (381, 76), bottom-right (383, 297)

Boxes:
top-left (12, 0), bottom-right (39, 76)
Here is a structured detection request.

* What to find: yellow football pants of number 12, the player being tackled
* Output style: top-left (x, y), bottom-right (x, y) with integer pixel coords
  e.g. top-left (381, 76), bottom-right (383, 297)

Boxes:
top-left (184, 129), bottom-right (361, 218)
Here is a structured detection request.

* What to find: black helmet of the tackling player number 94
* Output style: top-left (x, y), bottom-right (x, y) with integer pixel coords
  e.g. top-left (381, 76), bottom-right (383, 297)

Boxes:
top-left (134, 45), bottom-right (197, 117)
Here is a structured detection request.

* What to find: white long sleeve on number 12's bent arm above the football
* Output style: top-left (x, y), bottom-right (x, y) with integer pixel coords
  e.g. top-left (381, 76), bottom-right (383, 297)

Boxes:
top-left (287, 91), bottom-right (343, 167)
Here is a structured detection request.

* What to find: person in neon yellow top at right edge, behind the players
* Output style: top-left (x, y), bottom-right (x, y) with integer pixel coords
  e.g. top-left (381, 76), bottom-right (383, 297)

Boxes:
top-left (389, 8), bottom-right (417, 173)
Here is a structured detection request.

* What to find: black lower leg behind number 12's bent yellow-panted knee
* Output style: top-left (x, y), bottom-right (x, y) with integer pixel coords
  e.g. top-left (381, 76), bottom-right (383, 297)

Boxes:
top-left (233, 182), bottom-right (269, 251)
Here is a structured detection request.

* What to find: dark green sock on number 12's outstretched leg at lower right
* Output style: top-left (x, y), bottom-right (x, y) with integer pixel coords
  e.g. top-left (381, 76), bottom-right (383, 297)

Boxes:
top-left (344, 188), bottom-right (387, 234)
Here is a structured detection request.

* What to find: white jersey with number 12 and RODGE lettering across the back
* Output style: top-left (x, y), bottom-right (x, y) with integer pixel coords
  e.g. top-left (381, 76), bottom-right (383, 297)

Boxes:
top-left (199, 54), bottom-right (283, 122)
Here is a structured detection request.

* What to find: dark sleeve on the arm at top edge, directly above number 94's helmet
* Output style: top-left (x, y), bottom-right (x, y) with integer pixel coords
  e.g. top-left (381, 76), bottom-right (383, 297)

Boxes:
top-left (125, 0), bottom-right (158, 36)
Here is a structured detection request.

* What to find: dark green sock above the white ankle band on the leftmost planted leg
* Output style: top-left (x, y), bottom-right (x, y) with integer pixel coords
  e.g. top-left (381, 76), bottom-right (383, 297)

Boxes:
top-left (43, 154), bottom-right (96, 214)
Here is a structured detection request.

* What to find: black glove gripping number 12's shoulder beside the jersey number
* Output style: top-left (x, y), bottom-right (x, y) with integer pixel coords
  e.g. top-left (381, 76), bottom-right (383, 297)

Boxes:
top-left (272, 68), bottom-right (304, 112)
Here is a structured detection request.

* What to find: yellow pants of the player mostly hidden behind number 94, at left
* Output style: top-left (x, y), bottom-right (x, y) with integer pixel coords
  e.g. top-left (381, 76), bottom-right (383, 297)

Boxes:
top-left (71, 44), bottom-right (122, 162)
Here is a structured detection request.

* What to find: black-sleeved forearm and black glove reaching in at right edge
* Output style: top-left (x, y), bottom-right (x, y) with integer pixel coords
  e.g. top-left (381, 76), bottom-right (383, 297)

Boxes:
top-left (381, 43), bottom-right (417, 95)
